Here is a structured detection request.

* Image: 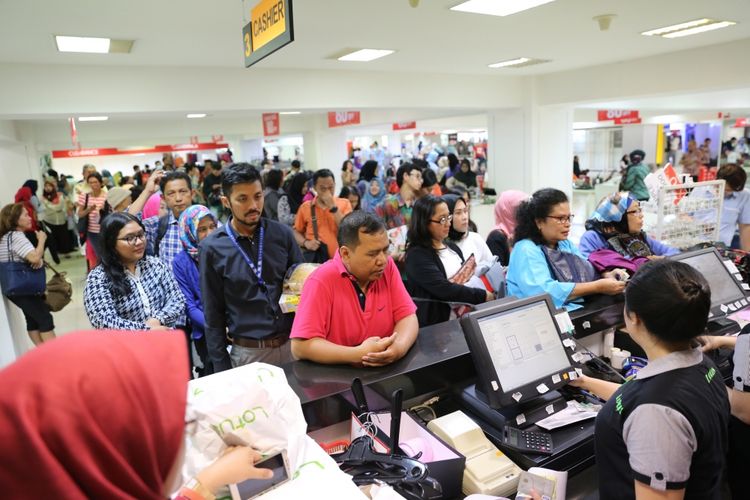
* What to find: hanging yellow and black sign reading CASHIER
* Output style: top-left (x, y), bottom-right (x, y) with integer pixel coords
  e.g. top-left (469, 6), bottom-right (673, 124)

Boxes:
top-left (242, 0), bottom-right (294, 68)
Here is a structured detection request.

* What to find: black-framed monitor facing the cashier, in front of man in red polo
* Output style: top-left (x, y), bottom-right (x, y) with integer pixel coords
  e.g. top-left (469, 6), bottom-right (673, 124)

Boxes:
top-left (461, 294), bottom-right (575, 408)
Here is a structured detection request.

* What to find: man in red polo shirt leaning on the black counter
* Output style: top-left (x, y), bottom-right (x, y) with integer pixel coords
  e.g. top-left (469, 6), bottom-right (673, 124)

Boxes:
top-left (290, 211), bottom-right (419, 366)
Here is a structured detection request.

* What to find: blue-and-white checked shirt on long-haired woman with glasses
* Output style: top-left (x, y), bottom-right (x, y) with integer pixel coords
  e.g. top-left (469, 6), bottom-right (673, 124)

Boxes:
top-left (83, 255), bottom-right (185, 330)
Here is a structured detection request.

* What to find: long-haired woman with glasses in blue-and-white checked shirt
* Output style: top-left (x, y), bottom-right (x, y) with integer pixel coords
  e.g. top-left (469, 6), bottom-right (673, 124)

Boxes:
top-left (83, 212), bottom-right (185, 330)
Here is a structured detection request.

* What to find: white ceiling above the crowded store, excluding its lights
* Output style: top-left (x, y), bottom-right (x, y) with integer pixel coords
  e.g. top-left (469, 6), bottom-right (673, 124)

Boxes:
top-left (0, 0), bottom-right (750, 75)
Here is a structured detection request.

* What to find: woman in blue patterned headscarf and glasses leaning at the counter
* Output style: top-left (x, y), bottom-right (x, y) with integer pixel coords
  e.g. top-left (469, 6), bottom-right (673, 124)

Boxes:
top-left (579, 192), bottom-right (679, 271)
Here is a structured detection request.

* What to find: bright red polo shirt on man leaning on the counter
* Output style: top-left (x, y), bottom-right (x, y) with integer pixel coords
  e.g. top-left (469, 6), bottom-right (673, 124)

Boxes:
top-left (290, 252), bottom-right (417, 347)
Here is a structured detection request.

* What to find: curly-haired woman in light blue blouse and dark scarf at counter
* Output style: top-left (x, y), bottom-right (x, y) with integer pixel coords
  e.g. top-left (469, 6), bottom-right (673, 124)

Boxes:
top-left (506, 188), bottom-right (625, 310)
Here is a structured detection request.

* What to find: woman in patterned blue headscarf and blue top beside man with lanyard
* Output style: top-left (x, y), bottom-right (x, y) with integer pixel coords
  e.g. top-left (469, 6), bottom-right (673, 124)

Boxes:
top-left (172, 205), bottom-right (219, 375)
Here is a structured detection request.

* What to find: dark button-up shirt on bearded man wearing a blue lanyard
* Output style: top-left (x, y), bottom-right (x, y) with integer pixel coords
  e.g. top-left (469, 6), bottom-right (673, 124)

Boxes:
top-left (200, 218), bottom-right (302, 371)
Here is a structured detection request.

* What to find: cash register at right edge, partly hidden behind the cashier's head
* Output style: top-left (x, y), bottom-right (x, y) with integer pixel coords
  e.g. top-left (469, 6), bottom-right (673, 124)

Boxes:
top-left (670, 247), bottom-right (750, 335)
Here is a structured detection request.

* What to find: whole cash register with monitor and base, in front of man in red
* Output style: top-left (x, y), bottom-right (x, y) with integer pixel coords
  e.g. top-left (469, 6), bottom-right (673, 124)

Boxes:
top-left (460, 294), bottom-right (594, 470)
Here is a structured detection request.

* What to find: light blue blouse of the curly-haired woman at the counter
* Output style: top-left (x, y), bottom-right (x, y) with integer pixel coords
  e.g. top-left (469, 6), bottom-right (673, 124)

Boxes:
top-left (506, 239), bottom-right (583, 311)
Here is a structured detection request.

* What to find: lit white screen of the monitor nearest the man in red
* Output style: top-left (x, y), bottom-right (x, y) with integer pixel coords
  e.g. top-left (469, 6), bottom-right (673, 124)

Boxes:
top-left (477, 298), bottom-right (570, 393)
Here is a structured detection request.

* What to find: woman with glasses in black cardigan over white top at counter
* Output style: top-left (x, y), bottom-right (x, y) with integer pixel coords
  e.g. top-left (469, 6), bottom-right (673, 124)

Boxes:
top-left (406, 195), bottom-right (494, 326)
